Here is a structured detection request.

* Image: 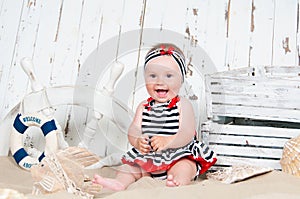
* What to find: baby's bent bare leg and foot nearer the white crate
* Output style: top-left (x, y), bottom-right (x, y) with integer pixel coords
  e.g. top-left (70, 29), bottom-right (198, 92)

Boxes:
top-left (166, 159), bottom-right (197, 187)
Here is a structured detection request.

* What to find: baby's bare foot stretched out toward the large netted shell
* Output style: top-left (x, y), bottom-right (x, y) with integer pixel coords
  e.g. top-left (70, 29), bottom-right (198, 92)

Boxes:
top-left (92, 174), bottom-right (125, 191)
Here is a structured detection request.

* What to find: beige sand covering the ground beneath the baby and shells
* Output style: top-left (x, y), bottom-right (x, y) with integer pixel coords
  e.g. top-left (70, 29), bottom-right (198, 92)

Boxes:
top-left (0, 157), bottom-right (300, 199)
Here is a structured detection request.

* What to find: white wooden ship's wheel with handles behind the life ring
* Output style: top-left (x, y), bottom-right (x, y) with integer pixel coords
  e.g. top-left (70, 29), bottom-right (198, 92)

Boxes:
top-left (1, 58), bottom-right (128, 162)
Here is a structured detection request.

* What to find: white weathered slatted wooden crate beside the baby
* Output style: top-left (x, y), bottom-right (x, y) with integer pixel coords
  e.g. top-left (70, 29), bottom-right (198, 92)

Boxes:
top-left (202, 66), bottom-right (300, 169)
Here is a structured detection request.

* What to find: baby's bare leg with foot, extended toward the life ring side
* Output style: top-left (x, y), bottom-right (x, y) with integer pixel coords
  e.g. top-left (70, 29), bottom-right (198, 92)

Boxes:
top-left (92, 165), bottom-right (143, 191)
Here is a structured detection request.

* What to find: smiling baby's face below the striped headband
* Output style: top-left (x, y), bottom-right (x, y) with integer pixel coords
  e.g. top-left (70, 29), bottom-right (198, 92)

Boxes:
top-left (145, 55), bottom-right (182, 103)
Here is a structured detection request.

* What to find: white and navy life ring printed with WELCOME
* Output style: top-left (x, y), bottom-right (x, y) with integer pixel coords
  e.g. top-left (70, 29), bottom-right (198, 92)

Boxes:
top-left (10, 113), bottom-right (58, 170)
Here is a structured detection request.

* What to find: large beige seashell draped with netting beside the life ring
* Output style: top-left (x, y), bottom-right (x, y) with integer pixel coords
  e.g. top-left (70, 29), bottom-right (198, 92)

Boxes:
top-left (31, 147), bottom-right (102, 199)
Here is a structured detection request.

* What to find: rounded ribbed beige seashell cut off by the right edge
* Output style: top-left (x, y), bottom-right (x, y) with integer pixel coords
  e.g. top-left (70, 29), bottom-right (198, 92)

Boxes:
top-left (280, 136), bottom-right (300, 177)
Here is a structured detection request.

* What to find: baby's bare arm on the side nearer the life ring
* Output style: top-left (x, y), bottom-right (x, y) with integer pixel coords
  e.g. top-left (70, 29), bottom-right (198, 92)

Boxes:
top-left (128, 102), bottom-right (151, 154)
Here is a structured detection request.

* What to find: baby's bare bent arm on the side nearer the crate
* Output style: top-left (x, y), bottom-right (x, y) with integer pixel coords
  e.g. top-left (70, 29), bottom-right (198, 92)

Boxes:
top-left (151, 97), bottom-right (195, 151)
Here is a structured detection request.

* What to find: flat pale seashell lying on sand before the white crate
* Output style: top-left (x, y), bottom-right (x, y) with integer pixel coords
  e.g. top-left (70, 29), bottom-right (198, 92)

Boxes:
top-left (207, 165), bottom-right (273, 184)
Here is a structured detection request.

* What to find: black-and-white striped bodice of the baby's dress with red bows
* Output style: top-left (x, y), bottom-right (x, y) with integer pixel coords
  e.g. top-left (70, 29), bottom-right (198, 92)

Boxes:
top-left (142, 97), bottom-right (179, 137)
